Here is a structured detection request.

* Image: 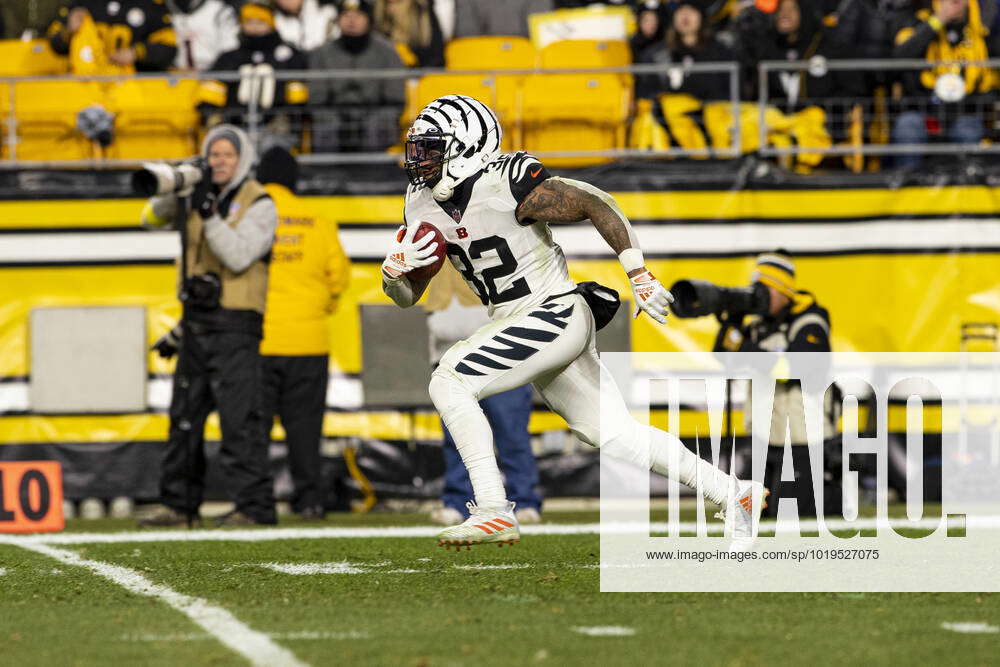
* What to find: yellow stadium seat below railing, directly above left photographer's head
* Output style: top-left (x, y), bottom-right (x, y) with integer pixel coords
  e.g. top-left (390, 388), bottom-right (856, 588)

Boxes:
top-left (106, 79), bottom-right (199, 159)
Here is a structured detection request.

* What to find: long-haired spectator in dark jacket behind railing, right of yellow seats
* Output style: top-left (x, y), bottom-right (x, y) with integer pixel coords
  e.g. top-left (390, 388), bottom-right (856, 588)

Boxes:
top-left (636, 2), bottom-right (734, 101)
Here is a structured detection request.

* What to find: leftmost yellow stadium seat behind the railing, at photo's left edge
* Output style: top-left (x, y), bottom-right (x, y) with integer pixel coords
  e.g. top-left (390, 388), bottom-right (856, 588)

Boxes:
top-left (4, 81), bottom-right (104, 160)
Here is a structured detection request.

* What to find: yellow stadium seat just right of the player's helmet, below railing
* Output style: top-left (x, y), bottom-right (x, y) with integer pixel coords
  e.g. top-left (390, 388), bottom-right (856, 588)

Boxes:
top-left (522, 74), bottom-right (632, 167)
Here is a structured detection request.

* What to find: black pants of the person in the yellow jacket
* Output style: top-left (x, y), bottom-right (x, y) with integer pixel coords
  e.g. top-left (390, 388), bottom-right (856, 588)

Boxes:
top-left (264, 354), bottom-right (330, 512)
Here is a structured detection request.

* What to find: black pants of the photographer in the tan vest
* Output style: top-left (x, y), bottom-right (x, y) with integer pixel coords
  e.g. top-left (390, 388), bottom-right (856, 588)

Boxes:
top-left (160, 325), bottom-right (277, 523)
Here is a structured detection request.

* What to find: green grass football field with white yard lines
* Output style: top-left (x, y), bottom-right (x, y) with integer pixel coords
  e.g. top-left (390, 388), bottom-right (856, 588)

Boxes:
top-left (0, 513), bottom-right (1000, 666)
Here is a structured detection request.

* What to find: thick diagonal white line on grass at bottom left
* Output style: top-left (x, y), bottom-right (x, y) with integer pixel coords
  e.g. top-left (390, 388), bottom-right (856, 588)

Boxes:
top-left (12, 542), bottom-right (306, 667)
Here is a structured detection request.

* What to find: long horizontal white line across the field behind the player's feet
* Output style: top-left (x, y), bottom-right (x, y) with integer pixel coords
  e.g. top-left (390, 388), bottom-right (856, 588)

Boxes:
top-left (0, 516), bottom-right (1000, 546)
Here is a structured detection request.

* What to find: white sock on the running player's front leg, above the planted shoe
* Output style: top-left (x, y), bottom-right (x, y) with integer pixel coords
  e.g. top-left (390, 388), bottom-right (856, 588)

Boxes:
top-left (441, 398), bottom-right (507, 508)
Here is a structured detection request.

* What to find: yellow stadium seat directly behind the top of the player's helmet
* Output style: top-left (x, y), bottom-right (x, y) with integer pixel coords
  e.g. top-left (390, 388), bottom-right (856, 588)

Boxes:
top-left (403, 74), bottom-right (522, 151)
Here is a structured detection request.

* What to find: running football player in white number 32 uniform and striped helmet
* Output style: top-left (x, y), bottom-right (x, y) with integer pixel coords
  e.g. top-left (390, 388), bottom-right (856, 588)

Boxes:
top-left (382, 95), bottom-right (769, 549)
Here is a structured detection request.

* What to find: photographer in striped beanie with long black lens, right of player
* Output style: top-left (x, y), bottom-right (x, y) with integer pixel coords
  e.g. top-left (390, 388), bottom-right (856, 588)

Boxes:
top-left (671, 250), bottom-right (840, 516)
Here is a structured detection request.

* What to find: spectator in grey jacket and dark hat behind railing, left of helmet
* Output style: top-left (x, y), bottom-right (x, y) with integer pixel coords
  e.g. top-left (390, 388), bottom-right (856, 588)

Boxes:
top-left (309, 0), bottom-right (404, 152)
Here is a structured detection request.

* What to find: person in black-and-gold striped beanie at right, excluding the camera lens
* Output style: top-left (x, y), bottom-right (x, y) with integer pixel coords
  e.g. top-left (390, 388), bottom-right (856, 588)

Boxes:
top-left (713, 250), bottom-right (840, 516)
